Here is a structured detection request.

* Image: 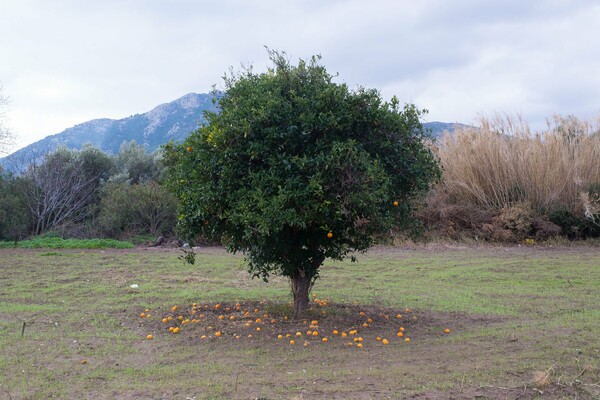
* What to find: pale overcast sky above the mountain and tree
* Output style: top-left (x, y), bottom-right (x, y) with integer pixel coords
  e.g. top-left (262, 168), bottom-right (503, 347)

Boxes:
top-left (0, 0), bottom-right (600, 152)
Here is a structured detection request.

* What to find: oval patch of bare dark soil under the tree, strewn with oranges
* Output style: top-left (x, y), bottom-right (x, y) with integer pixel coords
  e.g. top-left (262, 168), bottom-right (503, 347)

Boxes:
top-left (137, 298), bottom-right (504, 346)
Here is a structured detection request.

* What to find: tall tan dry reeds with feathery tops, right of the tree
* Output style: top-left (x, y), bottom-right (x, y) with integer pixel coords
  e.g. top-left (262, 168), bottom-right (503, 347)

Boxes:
top-left (437, 116), bottom-right (600, 215)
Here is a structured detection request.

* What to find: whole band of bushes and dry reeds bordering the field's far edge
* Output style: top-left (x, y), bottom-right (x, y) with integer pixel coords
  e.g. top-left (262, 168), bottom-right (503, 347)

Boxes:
top-left (0, 117), bottom-right (600, 243)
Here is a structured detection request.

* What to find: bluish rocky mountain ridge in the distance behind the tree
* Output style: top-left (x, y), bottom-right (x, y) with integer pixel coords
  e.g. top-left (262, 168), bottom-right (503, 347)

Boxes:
top-left (0, 93), bottom-right (467, 171)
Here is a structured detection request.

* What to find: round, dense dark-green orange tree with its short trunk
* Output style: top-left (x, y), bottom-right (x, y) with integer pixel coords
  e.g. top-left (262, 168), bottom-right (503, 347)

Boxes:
top-left (165, 52), bottom-right (440, 317)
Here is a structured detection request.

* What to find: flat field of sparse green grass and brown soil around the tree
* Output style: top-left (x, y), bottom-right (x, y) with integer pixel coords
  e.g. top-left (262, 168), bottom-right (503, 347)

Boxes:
top-left (0, 245), bottom-right (600, 399)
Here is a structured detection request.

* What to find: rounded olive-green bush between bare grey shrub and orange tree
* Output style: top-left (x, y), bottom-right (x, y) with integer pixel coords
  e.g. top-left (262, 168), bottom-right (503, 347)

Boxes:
top-left (98, 181), bottom-right (177, 237)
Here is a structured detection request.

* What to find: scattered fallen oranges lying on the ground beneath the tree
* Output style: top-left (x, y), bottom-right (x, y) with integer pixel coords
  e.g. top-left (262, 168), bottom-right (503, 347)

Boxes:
top-left (140, 298), bottom-right (450, 349)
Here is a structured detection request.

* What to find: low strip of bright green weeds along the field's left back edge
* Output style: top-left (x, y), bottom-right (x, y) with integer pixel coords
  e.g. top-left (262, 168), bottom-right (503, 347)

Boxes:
top-left (0, 236), bottom-right (133, 249)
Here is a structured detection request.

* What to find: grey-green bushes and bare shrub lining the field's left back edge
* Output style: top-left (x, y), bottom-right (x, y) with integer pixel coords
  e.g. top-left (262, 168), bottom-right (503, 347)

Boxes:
top-left (0, 142), bottom-right (177, 240)
